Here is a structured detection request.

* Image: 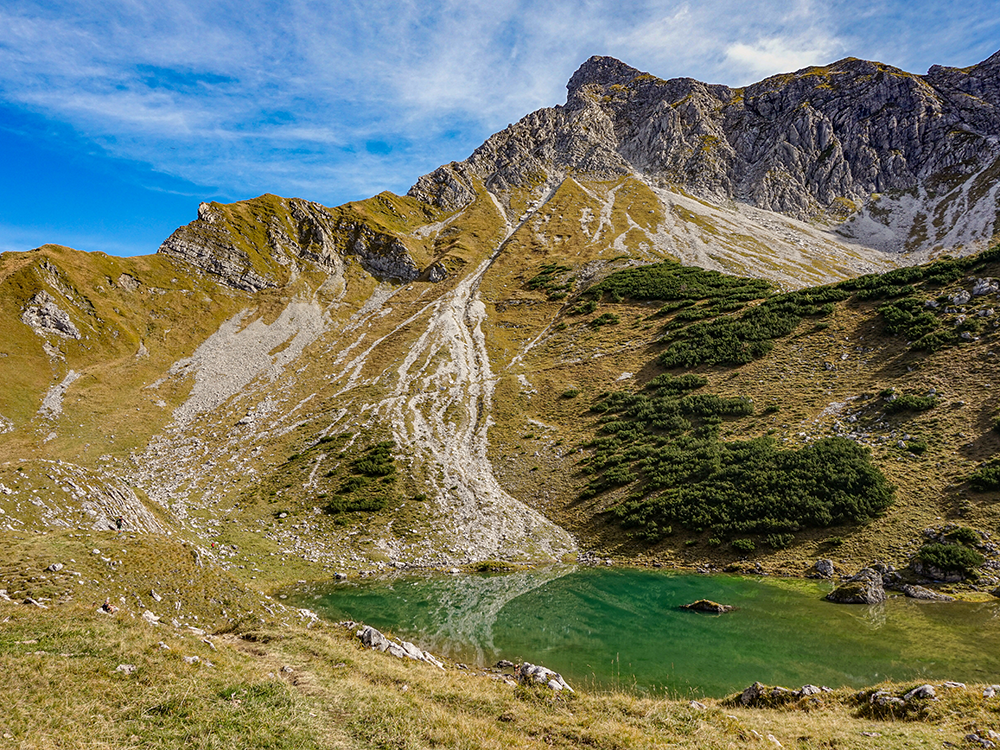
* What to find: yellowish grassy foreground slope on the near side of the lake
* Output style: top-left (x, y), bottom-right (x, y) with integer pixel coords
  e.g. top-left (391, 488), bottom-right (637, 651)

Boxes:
top-left (0, 532), bottom-right (1000, 749)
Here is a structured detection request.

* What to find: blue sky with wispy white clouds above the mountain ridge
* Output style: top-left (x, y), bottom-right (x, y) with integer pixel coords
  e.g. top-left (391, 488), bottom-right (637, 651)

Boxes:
top-left (0, 0), bottom-right (1000, 255)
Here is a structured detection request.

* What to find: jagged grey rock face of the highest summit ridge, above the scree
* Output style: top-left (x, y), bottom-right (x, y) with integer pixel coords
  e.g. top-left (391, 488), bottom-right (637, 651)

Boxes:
top-left (410, 53), bottom-right (1000, 256)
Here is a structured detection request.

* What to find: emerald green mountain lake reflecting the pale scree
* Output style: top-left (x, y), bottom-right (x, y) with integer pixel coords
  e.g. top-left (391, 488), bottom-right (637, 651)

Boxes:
top-left (289, 568), bottom-right (1000, 696)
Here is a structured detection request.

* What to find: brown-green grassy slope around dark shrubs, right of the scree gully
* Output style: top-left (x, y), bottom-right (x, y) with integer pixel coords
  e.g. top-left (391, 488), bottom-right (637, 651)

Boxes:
top-left (482, 238), bottom-right (1000, 573)
